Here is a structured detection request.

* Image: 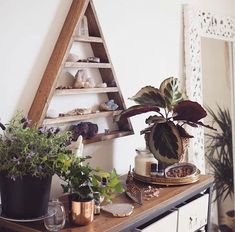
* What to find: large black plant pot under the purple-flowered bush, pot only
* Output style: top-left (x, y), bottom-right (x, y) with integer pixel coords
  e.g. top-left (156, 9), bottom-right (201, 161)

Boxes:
top-left (0, 174), bottom-right (52, 219)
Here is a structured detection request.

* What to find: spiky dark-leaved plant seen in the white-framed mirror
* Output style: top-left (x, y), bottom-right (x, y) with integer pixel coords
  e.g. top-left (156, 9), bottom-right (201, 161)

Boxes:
top-left (205, 106), bottom-right (235, 231)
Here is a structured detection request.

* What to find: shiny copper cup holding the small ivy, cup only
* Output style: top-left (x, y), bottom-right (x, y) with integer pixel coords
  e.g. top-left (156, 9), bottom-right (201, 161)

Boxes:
top-left (70, 200), bottom-right (94, 225)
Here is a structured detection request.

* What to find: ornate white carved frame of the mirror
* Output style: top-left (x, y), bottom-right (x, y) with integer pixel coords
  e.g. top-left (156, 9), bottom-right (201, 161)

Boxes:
top-left (184, 5), bottom-right (235, 173)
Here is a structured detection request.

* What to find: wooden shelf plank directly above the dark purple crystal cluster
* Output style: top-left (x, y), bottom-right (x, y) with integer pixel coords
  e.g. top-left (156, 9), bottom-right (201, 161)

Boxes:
top-left (43, 110), bottom-right (121, 125)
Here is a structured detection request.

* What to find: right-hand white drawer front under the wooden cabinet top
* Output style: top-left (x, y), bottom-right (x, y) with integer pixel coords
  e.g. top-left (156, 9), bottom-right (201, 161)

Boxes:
top-left (178, 194), bottom-right (209, 232)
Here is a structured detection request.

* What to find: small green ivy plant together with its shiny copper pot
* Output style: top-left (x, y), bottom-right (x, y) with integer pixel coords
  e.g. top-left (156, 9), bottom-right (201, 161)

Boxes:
top-left (60, 156), bottom-right (123, 225)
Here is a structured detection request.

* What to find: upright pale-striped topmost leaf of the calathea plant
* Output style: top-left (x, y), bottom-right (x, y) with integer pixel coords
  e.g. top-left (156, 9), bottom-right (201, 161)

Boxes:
top-left (160, 77), bottom-right (184, 111)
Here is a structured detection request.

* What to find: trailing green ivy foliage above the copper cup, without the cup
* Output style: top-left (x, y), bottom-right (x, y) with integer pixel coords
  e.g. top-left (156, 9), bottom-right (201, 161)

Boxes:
top-left (60, 159), bottom-right (123, 201)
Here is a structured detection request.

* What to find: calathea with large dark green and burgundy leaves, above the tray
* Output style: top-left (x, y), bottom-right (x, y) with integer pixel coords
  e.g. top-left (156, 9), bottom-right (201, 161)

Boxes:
top-left (116, 77), bottom-right (213, 165)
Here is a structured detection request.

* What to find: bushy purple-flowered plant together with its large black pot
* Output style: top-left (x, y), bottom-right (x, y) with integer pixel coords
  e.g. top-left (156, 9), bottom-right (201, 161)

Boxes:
top-left (0, 114), bottom-right (73, 219)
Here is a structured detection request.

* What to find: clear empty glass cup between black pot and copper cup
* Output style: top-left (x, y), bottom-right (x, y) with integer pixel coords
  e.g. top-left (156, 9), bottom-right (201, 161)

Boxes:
top-left (44, 199), bottom-right (66, 231)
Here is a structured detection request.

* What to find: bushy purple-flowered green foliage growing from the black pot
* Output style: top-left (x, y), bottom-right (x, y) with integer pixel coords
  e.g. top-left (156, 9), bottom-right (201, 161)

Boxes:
top-left (0, 113), bottom-right (73, 180)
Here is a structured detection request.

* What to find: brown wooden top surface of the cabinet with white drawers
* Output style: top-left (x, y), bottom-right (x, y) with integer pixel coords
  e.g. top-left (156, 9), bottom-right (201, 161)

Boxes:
top-left (62, 176), bottom-right (213, 232)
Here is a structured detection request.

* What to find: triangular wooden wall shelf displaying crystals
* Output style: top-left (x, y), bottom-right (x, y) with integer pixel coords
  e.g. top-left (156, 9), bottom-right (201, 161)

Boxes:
top-left (28, 0), bottom-right (133, 143)
